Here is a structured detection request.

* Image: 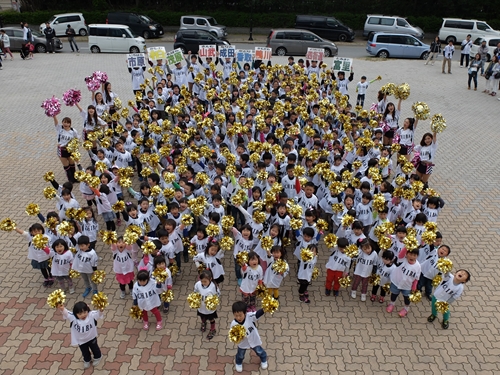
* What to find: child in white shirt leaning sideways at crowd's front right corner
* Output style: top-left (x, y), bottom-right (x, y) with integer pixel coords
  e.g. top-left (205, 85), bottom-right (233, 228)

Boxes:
top-left (427, 269), bottom-right (470, 329)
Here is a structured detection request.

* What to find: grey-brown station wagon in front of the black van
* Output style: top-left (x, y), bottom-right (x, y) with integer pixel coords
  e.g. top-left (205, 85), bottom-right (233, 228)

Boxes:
top-left (267, 29), bottom-right (338, 57)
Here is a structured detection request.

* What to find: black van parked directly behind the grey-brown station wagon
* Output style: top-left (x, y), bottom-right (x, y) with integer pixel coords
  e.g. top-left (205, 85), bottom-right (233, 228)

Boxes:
top-left (295, 16), bottom-right (356, 42)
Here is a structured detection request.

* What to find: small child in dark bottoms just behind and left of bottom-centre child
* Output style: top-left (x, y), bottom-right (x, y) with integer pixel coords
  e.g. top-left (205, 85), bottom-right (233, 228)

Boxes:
top-left (194, 270), bottom-right (220, 340)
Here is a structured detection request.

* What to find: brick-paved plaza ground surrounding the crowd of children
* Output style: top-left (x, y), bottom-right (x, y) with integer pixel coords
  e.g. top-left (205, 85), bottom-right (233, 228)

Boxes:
top-left (0, 54), bottom-right (500, 375)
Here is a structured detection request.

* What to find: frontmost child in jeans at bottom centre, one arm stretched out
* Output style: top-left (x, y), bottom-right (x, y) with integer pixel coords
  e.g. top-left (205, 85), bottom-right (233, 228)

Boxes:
top-left (231, 301), bottom-right (268, 372)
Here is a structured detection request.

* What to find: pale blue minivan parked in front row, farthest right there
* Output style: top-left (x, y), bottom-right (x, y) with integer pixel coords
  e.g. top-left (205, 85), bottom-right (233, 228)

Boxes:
top-left (366, 33), bottom-right (431, 60)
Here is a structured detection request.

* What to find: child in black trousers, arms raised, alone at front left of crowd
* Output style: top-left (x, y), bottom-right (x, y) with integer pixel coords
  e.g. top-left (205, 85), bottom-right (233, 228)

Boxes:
top-left (57, 302), bottom-right (104, 369)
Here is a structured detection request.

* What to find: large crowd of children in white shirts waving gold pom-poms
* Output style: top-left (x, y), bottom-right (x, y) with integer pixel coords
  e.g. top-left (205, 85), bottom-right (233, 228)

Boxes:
top-left (6, 55), bottom-right (470, 372)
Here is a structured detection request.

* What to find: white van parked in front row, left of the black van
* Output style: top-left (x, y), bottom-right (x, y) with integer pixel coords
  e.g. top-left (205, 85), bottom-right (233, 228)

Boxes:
top-left (89, 23), bottom-right (146, 53)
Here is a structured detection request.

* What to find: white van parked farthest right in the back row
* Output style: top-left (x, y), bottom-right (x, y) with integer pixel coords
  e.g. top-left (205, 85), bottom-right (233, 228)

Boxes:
top-left (439, 18), bottom-right (500, 44)
